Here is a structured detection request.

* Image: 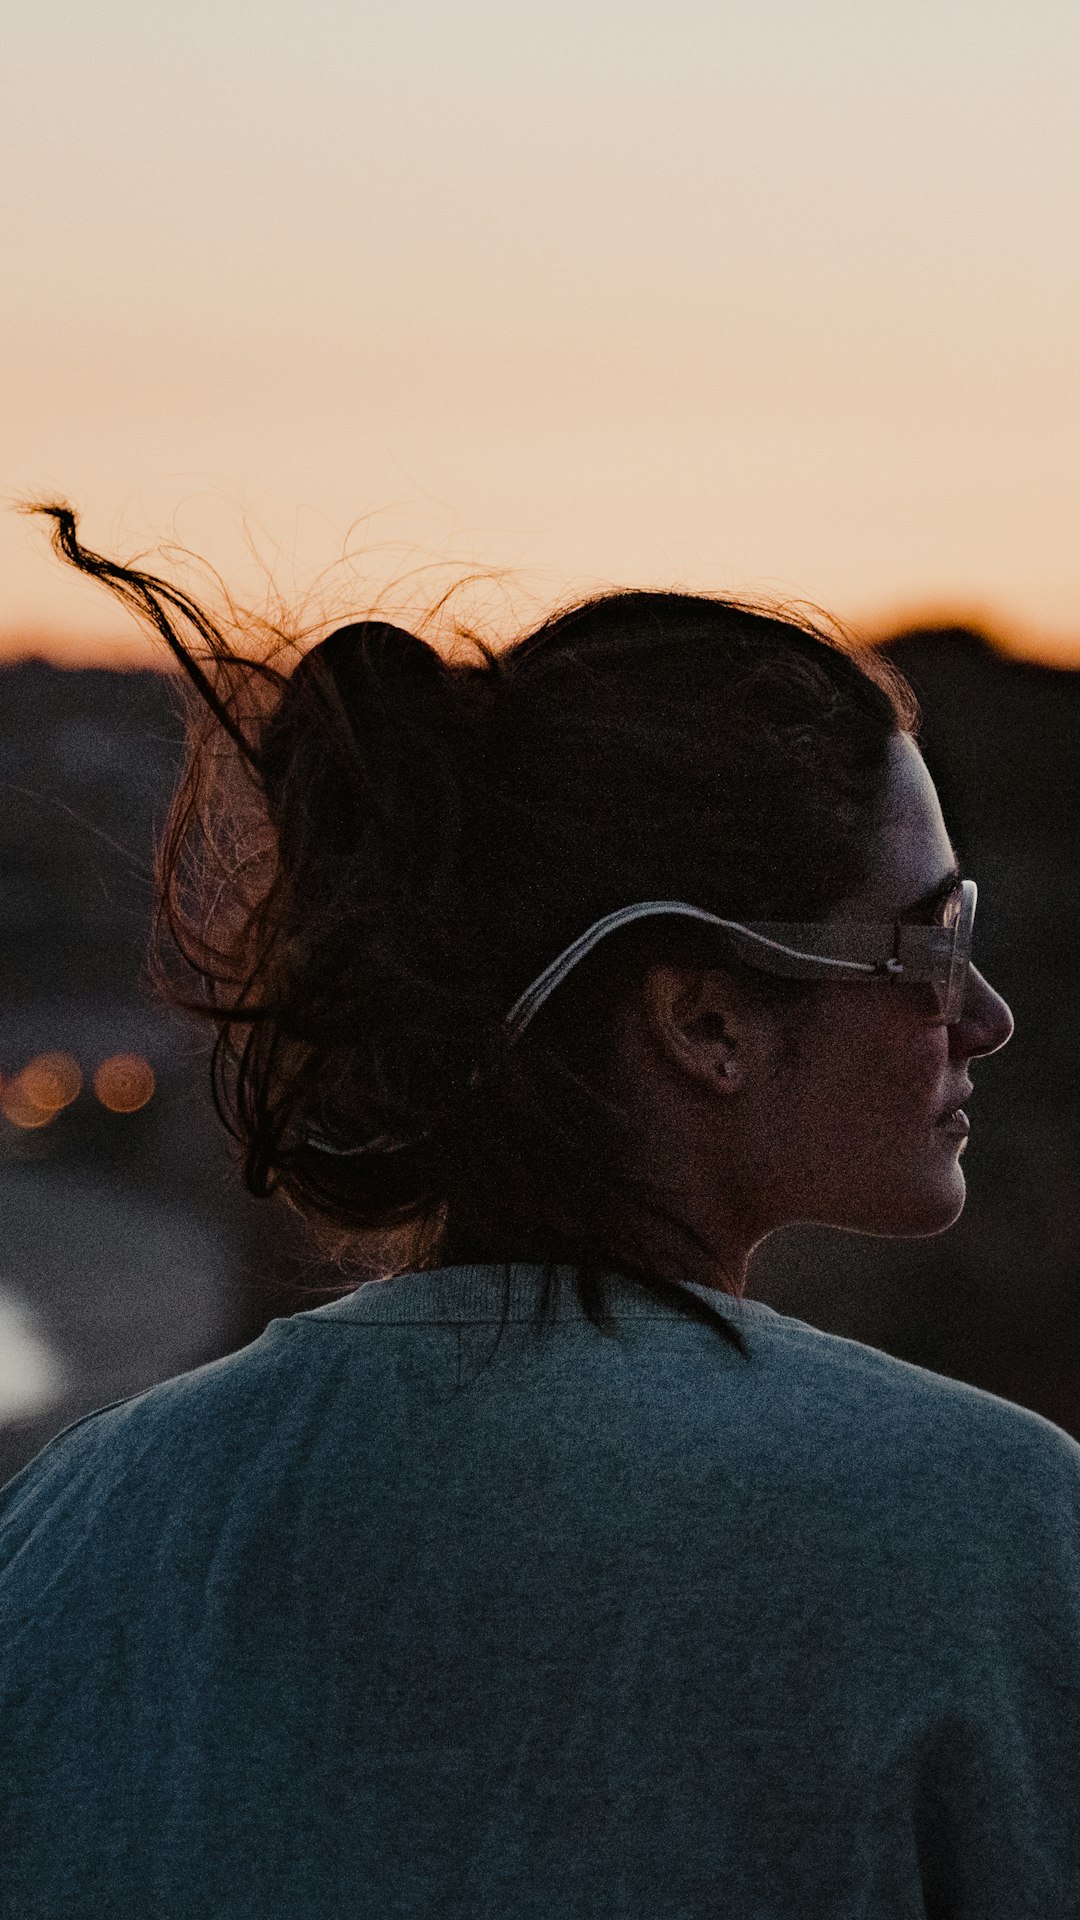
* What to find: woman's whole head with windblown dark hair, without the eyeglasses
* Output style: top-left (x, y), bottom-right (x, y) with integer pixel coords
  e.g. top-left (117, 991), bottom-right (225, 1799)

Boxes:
top-left (33, 503), bottom-right (1011, 1359)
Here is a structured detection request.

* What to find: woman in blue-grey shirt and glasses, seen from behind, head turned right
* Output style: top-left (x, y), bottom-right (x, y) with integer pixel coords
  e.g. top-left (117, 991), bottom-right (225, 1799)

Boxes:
top-left (0, 507), bottom-right (1080, 1920)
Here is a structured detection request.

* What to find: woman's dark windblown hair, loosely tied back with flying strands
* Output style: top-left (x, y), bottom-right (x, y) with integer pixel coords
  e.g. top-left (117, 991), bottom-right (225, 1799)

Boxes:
top-left (33, 505), bottom-right (920, 1356)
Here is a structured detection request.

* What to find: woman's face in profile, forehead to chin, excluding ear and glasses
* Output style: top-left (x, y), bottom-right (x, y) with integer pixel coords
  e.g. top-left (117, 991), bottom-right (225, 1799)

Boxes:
top-left (759, 733), bottom-right (1013, 1238)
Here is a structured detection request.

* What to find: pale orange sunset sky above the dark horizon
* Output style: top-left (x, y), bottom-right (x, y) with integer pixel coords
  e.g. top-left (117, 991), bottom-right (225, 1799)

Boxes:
top-left (0, 0), bottom-right (1080, 666)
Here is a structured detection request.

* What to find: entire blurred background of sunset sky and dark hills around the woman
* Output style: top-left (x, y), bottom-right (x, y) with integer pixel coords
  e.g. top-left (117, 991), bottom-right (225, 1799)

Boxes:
top-left (0, 0), bottom-right (1080, 1478)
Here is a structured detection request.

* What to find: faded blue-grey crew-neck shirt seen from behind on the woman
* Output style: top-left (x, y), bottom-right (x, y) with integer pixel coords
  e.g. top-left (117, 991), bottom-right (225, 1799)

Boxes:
top-left (0, 1267), bottom-right (1080, 1920)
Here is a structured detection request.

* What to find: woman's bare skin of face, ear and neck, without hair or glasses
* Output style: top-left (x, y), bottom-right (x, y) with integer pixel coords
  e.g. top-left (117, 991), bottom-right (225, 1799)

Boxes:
top-left (621, 732), bottom-right (1013, 1277)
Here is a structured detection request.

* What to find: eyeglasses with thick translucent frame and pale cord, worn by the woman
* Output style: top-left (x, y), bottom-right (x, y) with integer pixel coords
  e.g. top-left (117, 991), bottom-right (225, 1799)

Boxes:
top-left (505, 879), bottom-right (978, 1041)
